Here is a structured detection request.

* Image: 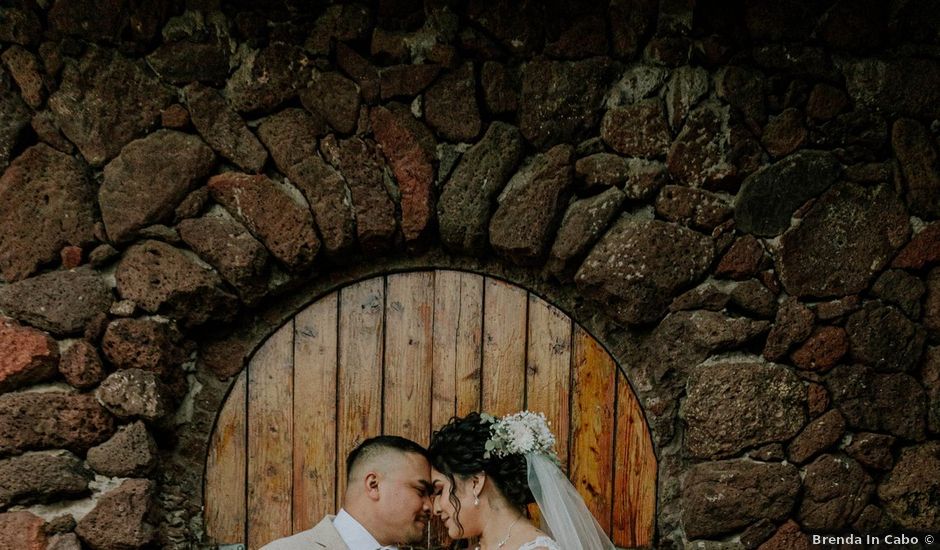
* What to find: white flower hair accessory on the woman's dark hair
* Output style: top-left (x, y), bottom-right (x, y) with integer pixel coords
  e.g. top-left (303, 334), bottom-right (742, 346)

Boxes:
top-left (480, 411), bottom-right (557, 461)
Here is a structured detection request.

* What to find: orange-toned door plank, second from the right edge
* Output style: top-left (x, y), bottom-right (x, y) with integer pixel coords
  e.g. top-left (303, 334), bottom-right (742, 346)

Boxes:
top-left (569, 327), bottom-right (616, 533)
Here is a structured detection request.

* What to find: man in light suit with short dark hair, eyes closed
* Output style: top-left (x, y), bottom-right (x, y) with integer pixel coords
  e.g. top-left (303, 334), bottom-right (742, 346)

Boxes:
top-left (261, 435), bottom-right (431, 550)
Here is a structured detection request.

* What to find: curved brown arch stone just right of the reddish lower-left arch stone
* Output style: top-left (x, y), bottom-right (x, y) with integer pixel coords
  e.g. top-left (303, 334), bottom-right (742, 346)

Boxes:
top-left (287, 155), bottom-right (356, 257)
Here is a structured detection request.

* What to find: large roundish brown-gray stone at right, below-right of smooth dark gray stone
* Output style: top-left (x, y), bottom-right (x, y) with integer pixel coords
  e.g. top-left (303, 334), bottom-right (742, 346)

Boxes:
top-left (776, 184), bottom-right (910, 298)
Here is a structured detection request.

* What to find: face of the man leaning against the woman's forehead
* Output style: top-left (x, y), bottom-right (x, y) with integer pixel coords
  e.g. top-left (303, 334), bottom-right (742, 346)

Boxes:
top-left (379, 453), bottom-right (431, 543)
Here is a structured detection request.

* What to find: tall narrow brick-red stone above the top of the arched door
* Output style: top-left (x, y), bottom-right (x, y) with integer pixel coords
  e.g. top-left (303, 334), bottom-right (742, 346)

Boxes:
top-left (371, 105), bottom-right (436, 246)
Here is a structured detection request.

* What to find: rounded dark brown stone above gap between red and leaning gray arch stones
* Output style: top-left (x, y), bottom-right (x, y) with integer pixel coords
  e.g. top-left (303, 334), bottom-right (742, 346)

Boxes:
top-left (424, 63), bottom-right (482, 142)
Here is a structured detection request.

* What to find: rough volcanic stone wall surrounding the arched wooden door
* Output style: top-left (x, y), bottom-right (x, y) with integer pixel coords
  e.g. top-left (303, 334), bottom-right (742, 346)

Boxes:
top-left (0, 0), bottom-right (940, 549)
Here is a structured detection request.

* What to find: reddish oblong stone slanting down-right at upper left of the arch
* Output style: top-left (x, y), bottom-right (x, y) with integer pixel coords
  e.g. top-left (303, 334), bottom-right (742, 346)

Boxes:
top-left (178, 216), bottom-right (269, 304)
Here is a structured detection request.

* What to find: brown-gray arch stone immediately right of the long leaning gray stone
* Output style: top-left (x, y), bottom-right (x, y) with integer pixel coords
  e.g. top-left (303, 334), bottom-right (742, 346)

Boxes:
top-left (490, 145), bottom-right (574, 265)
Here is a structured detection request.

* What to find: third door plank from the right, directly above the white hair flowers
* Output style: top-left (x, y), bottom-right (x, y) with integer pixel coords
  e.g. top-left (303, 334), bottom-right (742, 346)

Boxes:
top-left (525, 294), bottom-right (571, 470)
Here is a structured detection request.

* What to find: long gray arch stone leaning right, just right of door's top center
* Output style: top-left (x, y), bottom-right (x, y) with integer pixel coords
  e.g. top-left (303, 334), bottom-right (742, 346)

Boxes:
top-left (437, 122), bottom-right (522, 255)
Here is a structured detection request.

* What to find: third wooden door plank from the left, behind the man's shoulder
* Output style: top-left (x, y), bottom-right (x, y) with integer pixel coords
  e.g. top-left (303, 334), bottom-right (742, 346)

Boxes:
top-left (293, 298), bottom-right (338, 532)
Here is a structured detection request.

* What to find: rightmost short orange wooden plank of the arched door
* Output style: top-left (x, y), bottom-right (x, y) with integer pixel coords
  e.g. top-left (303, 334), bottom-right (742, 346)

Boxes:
top-left (612, 373), bottom-right (656, 547)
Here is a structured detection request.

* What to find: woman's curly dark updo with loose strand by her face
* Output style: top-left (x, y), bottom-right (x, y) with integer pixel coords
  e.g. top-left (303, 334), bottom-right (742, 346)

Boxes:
top-left (428, 412), bottom-right (535, 534)
